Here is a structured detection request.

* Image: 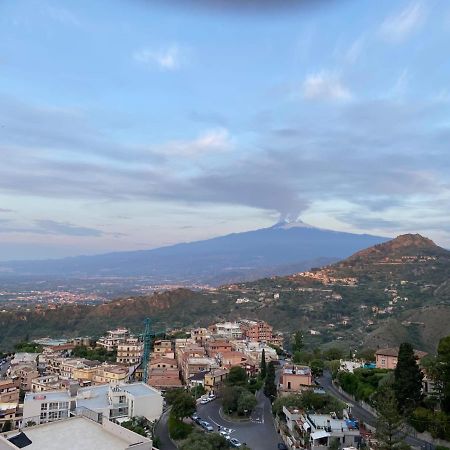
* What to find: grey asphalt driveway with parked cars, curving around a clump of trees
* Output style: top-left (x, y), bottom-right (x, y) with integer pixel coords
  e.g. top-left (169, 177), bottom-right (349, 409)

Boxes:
top-left (197, 391), bottom-right (282, 450)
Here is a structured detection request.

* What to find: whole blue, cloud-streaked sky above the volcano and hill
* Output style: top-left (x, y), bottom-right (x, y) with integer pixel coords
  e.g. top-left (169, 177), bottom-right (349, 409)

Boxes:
top-left (0, 0), bottom-right (450, 260)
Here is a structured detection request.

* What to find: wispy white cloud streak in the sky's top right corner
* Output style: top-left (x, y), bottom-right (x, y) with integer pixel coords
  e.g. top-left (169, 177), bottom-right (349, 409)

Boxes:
top-left (379, 2), bottom-right (426, 43)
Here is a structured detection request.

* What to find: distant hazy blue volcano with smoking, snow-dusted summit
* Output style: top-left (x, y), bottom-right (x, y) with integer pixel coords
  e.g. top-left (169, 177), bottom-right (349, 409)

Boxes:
top-left (0, 221), bottom-right (386, 285)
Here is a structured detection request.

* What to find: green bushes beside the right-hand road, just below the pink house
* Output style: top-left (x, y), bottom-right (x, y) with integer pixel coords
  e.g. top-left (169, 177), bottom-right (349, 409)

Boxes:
top-left (337, 369), bottom-right (388, 403)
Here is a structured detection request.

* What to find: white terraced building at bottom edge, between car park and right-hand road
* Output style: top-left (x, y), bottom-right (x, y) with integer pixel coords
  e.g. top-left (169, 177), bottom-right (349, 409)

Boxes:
top-left (282, 406), bottom-right (361, 450)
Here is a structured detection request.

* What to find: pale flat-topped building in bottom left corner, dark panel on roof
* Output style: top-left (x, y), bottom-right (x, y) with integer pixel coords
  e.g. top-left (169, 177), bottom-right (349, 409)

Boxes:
top-left (0, 416), bottom-right (156, 450)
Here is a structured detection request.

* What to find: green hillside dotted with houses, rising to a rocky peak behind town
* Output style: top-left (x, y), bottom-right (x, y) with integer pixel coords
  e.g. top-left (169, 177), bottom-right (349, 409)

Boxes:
top-left (0, 235), bottom-right (450, 352)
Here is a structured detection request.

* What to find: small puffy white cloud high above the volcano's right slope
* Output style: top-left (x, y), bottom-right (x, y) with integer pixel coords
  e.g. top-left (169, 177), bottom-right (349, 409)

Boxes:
top-left (302, 71), bottom-right (352, 100)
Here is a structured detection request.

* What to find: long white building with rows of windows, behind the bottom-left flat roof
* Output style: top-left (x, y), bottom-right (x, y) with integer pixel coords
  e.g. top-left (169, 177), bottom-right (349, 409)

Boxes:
top-left (23, 383), bottom-right (163, 424)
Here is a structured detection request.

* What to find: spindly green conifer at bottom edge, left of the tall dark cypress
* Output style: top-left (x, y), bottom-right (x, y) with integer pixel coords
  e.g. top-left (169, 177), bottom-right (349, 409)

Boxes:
top-left (375, 385), bottom-right (404, 450)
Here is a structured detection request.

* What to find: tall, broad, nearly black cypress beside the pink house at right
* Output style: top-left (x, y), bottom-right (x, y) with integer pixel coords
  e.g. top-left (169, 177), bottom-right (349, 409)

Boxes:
top-left (393, 342), bottom-right (423, 414)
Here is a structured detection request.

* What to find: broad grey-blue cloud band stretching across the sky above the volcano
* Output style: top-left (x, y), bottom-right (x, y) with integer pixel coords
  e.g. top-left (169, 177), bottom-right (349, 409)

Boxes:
top-left (0, 95), bottom-right (450, 235)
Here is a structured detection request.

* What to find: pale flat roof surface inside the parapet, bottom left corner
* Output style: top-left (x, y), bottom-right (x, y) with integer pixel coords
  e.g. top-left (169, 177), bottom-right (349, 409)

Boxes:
top-left (3, 417), bottom-right (144, 450)
